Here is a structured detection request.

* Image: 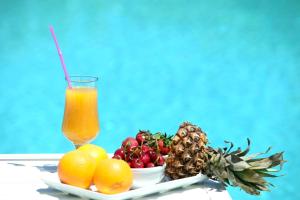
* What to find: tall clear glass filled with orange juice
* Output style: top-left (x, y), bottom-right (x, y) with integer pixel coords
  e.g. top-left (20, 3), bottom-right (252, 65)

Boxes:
top-left (62, 76), bottom-right (100, 148)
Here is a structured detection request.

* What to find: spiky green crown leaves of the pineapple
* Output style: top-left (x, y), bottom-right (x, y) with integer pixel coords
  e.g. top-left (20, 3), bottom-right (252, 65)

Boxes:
top-left (209, 139), bottom-right (286, 195)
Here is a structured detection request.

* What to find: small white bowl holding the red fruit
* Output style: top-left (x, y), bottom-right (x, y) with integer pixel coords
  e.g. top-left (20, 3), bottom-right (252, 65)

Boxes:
top-left (131, 164), bottom-right (166, 188)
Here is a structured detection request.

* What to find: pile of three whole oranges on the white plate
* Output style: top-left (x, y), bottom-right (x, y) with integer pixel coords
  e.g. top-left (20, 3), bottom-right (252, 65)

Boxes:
top-left (57, 144), bottom-right (133, 194)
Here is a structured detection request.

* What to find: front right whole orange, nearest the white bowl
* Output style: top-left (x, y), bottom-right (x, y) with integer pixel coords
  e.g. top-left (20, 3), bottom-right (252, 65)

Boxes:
top-left (94, 159), bottom-right (133, 194)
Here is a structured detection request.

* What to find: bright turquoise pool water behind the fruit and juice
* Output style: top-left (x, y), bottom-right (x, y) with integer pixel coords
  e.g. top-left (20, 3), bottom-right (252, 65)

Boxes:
top-left (0, 0), bottom-right (300, 200)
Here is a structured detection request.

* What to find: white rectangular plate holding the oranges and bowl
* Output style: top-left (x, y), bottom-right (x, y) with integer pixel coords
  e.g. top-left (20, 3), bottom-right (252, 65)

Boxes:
top-left (42, 173), bottom-right (207, 200)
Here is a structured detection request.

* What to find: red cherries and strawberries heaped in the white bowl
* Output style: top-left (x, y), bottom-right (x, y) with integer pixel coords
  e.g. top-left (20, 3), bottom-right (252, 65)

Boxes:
top-left (113, 130), bottom-right (172, 168)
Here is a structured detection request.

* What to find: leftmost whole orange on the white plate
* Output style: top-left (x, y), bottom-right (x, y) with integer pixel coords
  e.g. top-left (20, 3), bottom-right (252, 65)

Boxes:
top-left (57, 150), bottom-right (96, 189)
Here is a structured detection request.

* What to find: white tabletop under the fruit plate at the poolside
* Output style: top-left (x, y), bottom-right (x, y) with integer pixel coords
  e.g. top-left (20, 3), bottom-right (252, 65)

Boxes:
top-left (0, 154), bottom-right (231, 200)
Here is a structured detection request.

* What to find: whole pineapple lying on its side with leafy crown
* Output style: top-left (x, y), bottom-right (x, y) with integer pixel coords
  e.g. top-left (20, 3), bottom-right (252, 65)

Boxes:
top-left (165, 122), bottom-right (285, 195)
